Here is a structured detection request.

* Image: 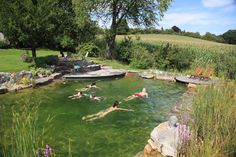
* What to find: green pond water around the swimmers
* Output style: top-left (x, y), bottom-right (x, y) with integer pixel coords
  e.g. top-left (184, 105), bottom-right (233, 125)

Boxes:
top-left (0, 78), bottom-right (186, 157)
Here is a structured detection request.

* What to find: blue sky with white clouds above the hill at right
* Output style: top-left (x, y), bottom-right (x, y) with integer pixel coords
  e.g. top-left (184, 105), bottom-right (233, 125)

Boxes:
top-left (158, 0), bottom-right (236, 35)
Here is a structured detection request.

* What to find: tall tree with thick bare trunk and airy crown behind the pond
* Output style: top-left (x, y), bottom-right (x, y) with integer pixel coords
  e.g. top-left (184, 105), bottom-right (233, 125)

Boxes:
top-left (77, 0), bottom-right (172, 58)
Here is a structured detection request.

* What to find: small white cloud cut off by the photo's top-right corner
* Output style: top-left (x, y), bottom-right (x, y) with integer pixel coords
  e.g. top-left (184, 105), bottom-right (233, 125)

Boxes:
top-left (202, 0), bottom-right (235, 8)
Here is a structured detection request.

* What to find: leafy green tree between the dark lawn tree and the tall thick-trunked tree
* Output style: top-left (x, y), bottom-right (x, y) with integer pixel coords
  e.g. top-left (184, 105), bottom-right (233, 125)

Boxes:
top-left (48, 0), bottom-right (96, 55)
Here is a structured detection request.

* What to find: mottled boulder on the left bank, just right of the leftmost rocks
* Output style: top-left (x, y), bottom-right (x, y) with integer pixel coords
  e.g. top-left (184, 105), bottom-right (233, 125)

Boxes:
top-left (10, 71), bottom-right (33, 83)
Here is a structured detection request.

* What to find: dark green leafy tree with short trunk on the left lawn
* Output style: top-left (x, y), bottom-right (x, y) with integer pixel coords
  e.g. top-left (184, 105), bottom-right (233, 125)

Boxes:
top-left (0, 0), bottom-right (57, 62)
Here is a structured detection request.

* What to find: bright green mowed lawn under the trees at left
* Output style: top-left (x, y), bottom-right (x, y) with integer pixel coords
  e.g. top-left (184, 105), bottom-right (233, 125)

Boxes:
top-left (0, 49), bottom-right (59, 72)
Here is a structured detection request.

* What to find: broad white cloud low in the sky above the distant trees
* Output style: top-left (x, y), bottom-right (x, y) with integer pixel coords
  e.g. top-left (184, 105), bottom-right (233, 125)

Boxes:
top-left (159, 12), bottom-right (235, 34)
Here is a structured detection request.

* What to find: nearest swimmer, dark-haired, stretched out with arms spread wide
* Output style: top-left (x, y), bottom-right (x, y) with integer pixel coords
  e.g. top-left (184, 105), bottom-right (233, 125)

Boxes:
top-left (82, 101), bottom-right (134, 121)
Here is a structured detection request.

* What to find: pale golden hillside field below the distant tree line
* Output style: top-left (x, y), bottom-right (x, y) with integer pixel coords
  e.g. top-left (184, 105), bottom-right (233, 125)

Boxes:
top-left (117, 34), bottom-right (236, 51)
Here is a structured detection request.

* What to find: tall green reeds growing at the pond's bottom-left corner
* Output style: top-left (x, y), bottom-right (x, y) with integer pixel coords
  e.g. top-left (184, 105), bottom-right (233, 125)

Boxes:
top-left (2, 99), bottom-right (43, 157)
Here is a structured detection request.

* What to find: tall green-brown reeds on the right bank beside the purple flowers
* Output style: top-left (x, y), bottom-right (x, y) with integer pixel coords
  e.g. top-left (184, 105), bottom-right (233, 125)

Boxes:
top-left (182, 83), bottom-right (236, 157)
